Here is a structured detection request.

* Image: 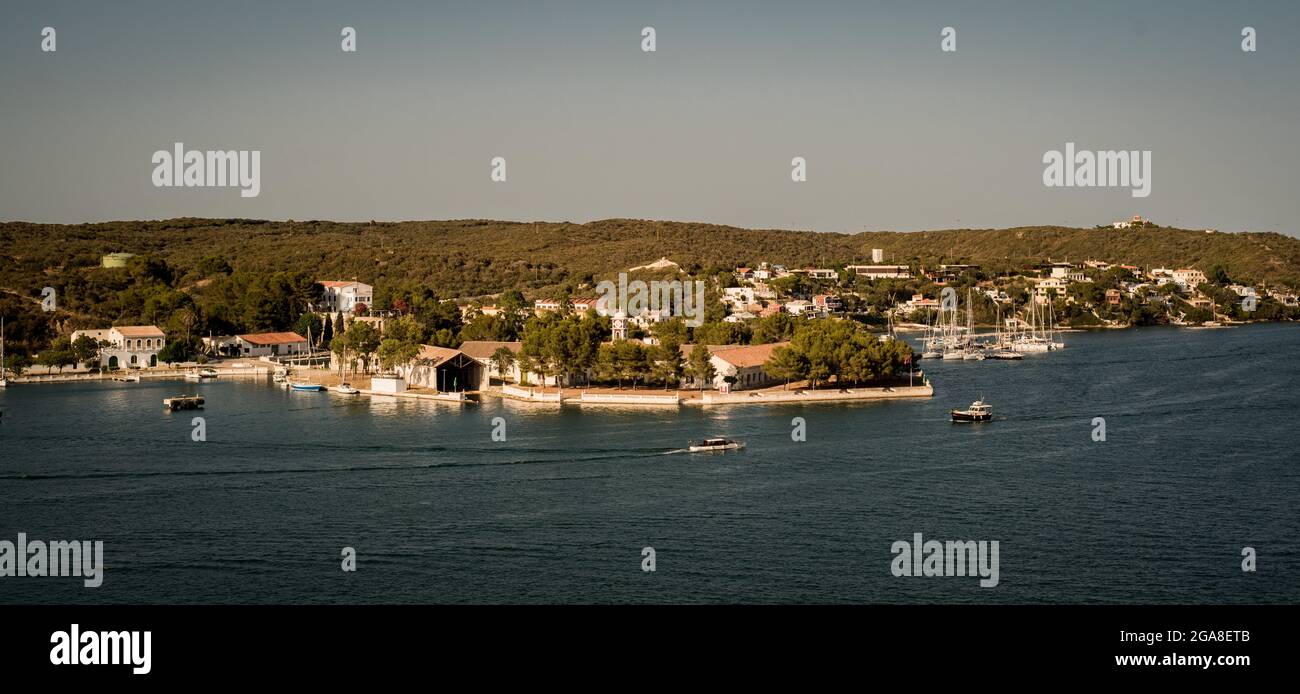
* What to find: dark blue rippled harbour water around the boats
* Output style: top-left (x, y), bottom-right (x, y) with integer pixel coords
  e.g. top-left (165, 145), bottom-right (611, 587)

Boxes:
top-left (0, 325), bottom-right (1300, 603)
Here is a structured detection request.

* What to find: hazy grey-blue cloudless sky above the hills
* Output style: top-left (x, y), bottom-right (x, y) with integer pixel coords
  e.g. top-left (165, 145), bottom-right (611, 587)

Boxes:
top-left (0, 0), bottom-right (1300, 235)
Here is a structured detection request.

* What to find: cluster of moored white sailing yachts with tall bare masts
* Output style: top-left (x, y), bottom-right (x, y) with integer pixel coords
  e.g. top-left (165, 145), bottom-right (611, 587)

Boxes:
top-left (922, 292), bottom-right (1065, 361)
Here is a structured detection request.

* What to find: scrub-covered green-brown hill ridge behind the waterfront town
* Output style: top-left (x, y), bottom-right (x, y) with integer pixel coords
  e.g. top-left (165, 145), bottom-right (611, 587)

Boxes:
top-left (0, 218), bottom-right (1300, 296)
